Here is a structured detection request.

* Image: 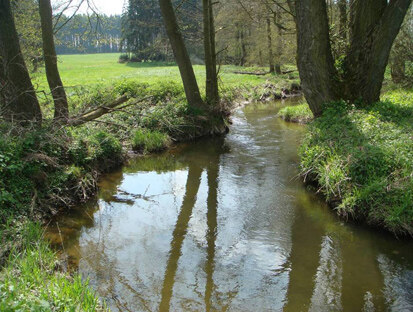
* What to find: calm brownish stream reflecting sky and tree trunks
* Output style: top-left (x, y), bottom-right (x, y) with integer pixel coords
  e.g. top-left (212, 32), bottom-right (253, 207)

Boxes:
top-left (48, 102), bottom-right (413, 311)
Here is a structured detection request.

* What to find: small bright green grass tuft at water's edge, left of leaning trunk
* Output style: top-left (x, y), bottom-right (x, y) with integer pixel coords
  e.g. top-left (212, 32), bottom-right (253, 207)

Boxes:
top-left (132, 130), bottom-right (170, 153)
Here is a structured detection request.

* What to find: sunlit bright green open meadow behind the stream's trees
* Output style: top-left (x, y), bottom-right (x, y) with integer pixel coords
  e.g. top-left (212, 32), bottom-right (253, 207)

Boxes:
top-left (33, 53), bottom-right (298, 90)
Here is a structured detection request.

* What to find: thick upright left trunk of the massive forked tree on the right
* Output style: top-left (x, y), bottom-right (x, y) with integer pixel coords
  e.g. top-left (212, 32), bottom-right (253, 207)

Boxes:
top-left (296, 0), bottom-right (337, 117)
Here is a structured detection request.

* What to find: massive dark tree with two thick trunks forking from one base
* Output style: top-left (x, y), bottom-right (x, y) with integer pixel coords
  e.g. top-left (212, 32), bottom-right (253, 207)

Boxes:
top-left (295, 0), bottom-right (411, 116)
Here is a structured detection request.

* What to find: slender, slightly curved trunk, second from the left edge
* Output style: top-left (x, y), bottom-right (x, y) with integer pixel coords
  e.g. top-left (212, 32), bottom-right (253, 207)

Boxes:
top-left (39, 0), bottom-right (69, 122)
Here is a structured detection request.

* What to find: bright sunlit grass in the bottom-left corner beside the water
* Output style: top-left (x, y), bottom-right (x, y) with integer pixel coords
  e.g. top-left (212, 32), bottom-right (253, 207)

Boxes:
top-left (0, 222), bottom-right (106, 312)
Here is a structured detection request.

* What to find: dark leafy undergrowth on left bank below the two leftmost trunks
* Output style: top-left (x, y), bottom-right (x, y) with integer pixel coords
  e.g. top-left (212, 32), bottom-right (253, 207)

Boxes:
top-left (0, 128), bottom-right (123, 223)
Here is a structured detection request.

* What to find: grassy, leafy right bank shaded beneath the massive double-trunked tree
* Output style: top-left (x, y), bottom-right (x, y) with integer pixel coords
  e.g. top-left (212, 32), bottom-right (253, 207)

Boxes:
top-left (300, 91), bottom-right (413, 235)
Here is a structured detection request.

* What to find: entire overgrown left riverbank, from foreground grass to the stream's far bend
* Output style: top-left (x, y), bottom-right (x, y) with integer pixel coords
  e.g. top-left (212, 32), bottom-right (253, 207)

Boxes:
top-left (0, 65), bottom-right (300, 311)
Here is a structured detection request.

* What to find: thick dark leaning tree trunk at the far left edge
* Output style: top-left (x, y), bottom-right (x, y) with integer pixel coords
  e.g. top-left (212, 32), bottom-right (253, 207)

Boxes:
top-left (0, 0), bottom-right (42, 124)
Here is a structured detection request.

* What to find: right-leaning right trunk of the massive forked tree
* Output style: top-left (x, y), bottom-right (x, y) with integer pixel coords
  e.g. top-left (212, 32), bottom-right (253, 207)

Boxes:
top-left (345, 0), bottom-right (411, 104)
